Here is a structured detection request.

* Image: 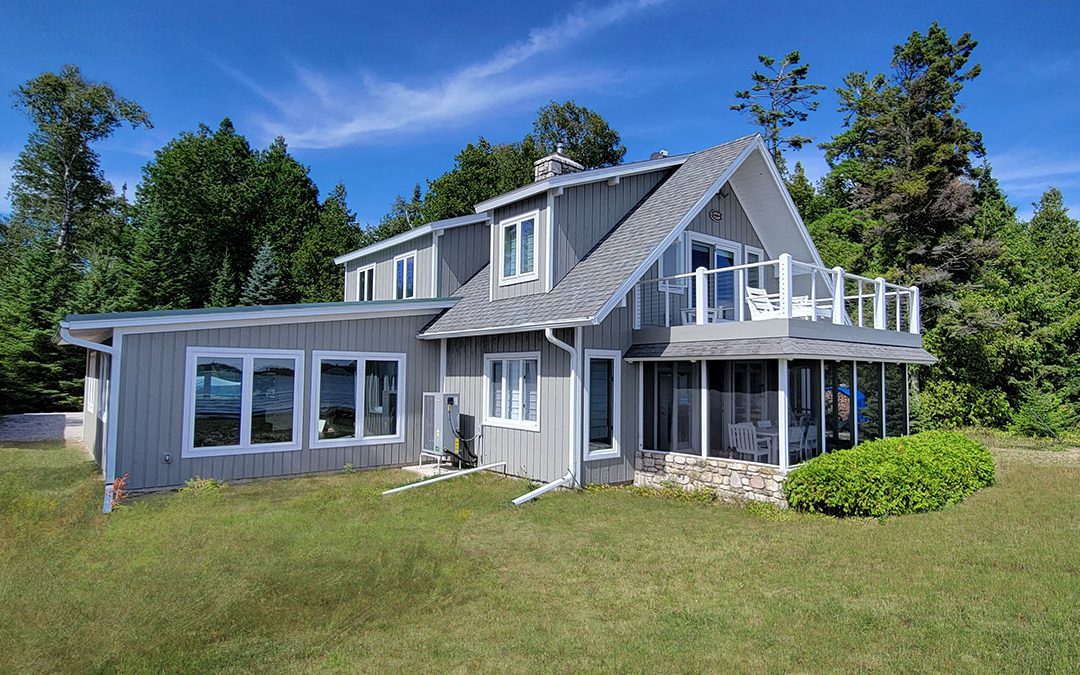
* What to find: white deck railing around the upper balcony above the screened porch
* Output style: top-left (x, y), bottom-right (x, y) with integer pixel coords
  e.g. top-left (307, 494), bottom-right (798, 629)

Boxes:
top-left (633, 254), bottom-right (920, 335)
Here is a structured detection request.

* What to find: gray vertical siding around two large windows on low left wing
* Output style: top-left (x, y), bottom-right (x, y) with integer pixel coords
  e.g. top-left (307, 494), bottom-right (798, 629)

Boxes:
top-left (114, 315), bottom-right (438, 488)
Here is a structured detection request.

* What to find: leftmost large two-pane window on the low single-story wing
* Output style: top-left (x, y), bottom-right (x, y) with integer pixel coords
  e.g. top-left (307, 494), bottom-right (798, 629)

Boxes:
top-left (183, 347), bottom-right (303, 457)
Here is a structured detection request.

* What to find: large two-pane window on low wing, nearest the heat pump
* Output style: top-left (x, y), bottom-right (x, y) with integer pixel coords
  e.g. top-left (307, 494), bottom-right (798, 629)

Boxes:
top-left (311, 351), bottom-right (405, 447)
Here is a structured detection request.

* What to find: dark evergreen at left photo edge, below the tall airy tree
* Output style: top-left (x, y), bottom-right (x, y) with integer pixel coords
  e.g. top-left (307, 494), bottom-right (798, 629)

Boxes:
top-left (0, 232), bottom-right (85, 413)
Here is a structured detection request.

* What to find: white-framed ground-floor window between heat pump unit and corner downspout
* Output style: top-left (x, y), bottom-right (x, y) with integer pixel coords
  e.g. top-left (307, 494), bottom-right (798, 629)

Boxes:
top-left (484, 352), bottom-right (540, 431)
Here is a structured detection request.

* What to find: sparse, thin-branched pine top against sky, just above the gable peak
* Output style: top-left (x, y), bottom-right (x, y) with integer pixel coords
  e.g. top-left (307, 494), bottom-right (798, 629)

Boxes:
top-left (731, 51), bottom-right (825, 175)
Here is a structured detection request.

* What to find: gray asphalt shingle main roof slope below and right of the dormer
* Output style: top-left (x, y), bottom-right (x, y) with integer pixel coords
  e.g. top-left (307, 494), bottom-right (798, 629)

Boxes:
top-left (422, 136), bottom-right (756, 337)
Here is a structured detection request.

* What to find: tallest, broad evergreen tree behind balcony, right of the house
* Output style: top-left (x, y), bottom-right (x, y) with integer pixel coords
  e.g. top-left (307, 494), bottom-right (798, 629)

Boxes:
top-left (823, 23), bottom-right (988, 298)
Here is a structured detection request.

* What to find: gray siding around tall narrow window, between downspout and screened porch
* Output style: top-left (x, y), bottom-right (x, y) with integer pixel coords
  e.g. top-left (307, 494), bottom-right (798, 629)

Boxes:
top-left (581, 307), bottom-right (642, 484)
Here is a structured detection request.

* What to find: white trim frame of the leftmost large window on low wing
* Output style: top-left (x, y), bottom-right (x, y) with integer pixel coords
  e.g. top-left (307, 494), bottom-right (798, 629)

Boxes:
top-left (180, 347), bottom-right (303, 459)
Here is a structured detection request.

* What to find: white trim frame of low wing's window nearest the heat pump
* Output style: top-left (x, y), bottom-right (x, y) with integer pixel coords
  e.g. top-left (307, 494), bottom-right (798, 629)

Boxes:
top-left (308, 350), bottom-right (407, 449)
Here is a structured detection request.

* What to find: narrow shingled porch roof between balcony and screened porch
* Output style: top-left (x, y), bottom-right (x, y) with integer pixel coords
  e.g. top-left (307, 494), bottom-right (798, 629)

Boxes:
top-left (625, 337), bottom-right (937, 365)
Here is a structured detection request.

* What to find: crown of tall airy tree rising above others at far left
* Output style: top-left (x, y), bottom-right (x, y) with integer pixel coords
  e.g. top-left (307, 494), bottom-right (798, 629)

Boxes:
top-left (11, 66), bottom-right (151, 251)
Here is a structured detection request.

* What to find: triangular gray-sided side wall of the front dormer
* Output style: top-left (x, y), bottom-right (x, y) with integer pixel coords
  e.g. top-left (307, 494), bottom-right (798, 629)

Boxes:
top-left (552, 168), bottom-right (674, 286)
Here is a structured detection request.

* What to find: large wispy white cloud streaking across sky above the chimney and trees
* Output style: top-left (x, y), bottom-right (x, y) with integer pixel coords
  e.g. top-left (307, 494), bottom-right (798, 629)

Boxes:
top-left (219, 0), bottom-right (664, 148)
